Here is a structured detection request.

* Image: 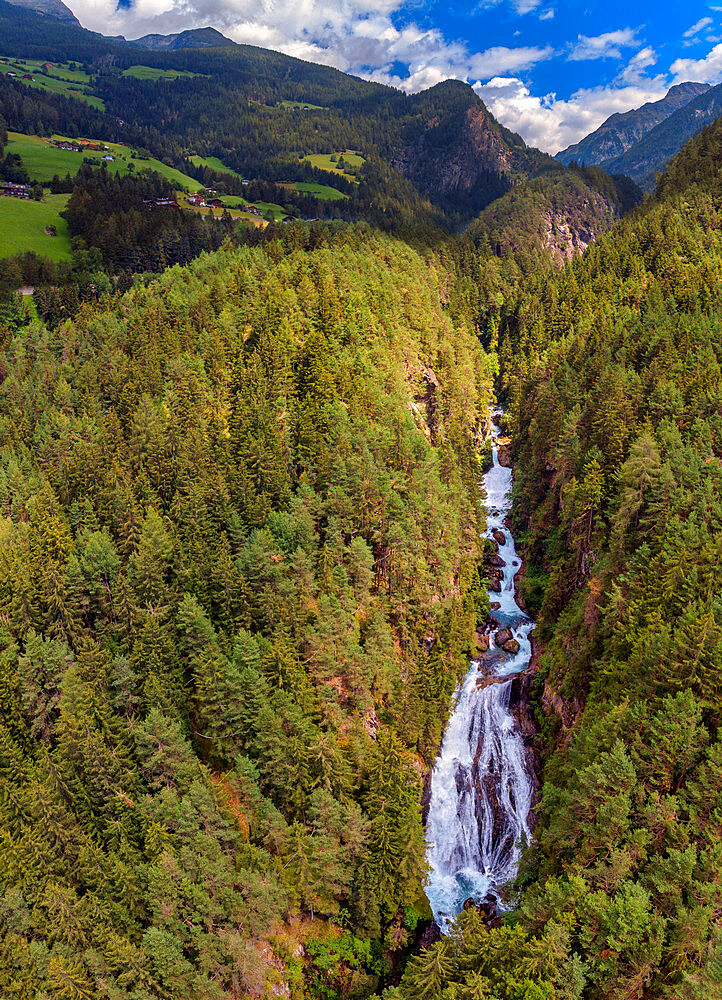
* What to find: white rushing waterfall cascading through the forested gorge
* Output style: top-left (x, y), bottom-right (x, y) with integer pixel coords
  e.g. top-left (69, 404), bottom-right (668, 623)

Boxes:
top-left (426, 412), bottom-right (534, 931)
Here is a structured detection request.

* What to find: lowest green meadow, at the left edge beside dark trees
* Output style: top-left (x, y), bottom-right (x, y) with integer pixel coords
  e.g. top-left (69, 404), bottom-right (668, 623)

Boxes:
top-left (0, 194), bottom-right (70, 260)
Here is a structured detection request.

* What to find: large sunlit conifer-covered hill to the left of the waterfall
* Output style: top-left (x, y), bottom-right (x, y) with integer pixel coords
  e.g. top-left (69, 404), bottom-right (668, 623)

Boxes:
top-left (0, 230), bottom-right (500, 1000)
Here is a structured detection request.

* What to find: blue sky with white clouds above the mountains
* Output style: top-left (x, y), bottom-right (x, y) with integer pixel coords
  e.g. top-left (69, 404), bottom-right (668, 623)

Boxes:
top-left (69, 0), bottom-right (722, 153)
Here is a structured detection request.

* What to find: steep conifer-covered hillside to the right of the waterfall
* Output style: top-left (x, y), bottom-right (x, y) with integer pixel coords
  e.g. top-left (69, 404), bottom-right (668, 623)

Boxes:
top-left (401, 107), bottom-right (722, 1000)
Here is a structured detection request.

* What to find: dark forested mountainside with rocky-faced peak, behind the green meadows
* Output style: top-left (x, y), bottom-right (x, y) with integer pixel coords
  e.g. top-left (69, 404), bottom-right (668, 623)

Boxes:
top-left (0, 0), bottom-right (568, 230)
